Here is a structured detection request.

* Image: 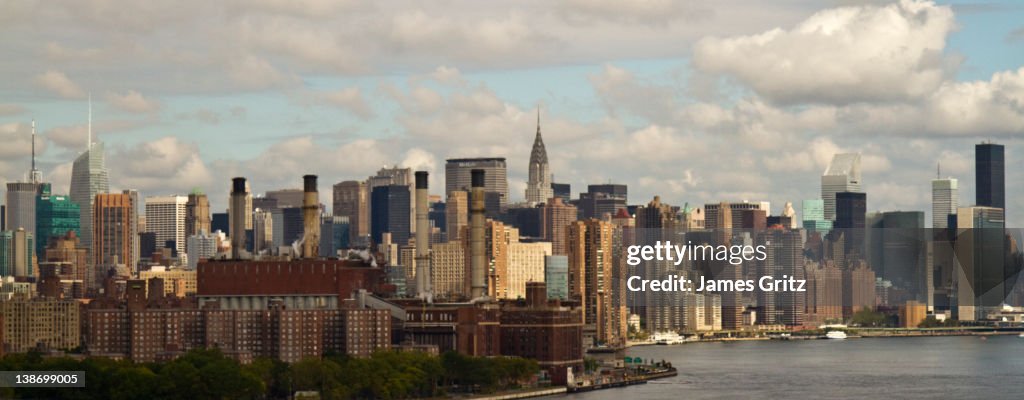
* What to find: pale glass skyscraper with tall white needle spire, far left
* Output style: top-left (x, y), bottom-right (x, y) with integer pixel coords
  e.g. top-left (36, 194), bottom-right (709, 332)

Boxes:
top-left (69, 100), bottom-right (111, 249)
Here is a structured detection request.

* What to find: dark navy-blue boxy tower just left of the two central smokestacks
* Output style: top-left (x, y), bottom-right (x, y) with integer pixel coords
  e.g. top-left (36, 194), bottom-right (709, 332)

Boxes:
top-left (370, 185), bottom-right (412, 246)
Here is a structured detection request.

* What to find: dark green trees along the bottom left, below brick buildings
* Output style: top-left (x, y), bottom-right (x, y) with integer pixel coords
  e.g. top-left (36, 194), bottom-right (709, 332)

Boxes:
top-left (0, 349), bottom-right (540, 400)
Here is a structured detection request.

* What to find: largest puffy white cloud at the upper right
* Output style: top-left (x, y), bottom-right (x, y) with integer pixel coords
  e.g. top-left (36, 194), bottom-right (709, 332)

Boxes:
top-left (693, 0), bottom-right (955, 104)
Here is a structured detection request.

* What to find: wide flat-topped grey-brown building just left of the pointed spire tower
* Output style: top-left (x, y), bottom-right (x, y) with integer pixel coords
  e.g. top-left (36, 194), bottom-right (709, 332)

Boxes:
top-left (444, 158), bottom-right (509, 211)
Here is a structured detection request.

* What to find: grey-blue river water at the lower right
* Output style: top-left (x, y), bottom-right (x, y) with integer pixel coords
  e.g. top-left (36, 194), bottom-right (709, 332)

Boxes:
top-left (559, 336), bottom-right (1024, 400)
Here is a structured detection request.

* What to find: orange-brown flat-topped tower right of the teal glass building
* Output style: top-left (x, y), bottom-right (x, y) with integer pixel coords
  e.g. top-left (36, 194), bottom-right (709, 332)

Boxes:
top-left (93, 190), bottom-right (138, 283)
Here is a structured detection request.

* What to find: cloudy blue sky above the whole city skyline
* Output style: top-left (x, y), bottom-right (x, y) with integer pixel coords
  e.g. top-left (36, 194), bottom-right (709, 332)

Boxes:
top-left (0, 0), bottom-right (1024, 226)
